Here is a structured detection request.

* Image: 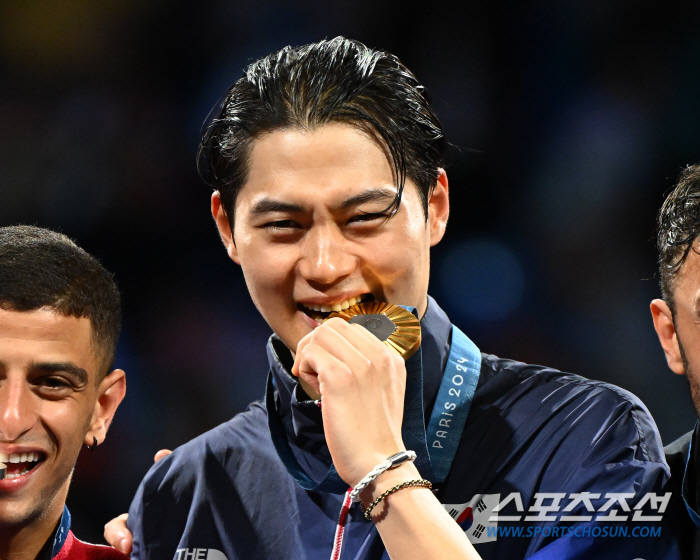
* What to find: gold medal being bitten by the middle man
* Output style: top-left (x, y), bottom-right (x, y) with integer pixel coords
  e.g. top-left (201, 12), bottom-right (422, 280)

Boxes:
top-left (324, 301), bottom-right (420, 360)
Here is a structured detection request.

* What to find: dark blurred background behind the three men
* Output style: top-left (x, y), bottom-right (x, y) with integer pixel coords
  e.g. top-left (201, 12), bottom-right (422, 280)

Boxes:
top-left (0, 0), bottom-right (700, 542)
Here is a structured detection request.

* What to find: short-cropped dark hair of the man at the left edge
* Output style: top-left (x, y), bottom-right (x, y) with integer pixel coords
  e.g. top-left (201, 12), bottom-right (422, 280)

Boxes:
top-left (0, 226), bottom-right (121, 380)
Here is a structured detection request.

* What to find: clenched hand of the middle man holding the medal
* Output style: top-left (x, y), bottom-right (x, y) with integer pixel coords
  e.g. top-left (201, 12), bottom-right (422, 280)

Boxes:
top-left (292, 318), bottom-right (406, 486)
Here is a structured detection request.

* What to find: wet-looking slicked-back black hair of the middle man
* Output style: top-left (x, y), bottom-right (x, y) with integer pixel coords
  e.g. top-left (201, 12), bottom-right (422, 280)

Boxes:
top-left (198, 37), bottom-right (447, 229)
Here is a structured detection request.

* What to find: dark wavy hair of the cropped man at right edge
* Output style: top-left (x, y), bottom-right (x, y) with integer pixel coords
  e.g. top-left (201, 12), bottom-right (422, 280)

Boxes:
top-left (656, 165), bottom-right (700, 313)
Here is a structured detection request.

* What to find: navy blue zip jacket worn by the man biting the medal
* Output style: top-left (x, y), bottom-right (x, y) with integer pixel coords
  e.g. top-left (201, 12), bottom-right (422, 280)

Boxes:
top-left (128, 299), bottom-right (677, 560)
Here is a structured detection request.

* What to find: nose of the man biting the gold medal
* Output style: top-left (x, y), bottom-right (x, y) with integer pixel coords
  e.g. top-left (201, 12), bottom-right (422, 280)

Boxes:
top-left (299, 225), bottom-right (356, 284)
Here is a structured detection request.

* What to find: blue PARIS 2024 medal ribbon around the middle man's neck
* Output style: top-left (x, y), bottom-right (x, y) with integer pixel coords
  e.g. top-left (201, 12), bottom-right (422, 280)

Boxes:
top-left (265, 320), bottom-right (481, 494)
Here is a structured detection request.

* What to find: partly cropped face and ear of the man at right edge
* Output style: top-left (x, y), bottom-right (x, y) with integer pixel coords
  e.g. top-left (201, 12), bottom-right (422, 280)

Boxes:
top-left (651, 240), bottom-right (700, 414)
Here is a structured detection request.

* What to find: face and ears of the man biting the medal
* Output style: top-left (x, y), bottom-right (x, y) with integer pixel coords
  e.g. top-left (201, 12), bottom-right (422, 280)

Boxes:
top-left (212, 124), bottom-right (449, 350)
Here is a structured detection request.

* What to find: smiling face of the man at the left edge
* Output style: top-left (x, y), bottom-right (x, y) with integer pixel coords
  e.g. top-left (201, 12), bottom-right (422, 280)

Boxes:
top-left (0, 309), bottom-right (123, 528)
